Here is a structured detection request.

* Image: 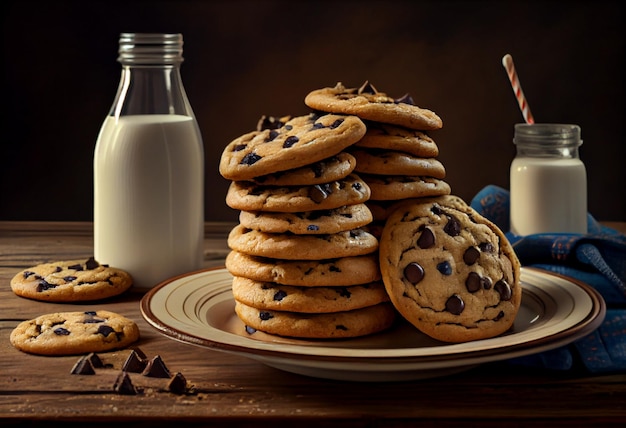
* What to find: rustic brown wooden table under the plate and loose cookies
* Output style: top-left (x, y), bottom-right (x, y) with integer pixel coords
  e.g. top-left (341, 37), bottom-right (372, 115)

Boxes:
top-left (0, 222), bottom-right (626, 427)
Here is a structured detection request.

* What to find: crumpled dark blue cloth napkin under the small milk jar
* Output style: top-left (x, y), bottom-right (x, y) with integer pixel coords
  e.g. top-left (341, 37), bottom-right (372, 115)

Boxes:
top-left (470, 185), bottom-right (626, 373)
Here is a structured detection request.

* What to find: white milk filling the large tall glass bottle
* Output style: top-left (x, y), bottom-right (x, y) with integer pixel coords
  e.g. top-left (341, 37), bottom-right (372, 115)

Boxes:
top-left (94, 115), bottom-right (204, 288)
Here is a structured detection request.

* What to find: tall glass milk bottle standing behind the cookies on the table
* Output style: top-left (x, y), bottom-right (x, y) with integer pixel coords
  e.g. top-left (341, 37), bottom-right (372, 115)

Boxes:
top-left (94, 33), bottom-right (204, 289)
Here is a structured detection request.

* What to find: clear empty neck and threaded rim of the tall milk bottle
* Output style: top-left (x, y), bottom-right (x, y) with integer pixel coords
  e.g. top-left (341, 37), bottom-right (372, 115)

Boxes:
top-left (109, 33), bottom-right (193, 117)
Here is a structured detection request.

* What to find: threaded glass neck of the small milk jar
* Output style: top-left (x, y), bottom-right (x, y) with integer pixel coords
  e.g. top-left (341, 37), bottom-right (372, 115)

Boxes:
top-left (513, 123), bottom-right (582, 159)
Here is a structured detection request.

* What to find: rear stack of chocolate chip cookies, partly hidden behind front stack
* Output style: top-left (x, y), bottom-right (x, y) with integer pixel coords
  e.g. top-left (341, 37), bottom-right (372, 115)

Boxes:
top-left (305, 82), bottom-right (450, 236)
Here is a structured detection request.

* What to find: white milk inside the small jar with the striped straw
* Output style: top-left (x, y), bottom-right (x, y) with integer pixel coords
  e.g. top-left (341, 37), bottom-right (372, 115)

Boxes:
top-left (510, 157), bottom-right (587, 235)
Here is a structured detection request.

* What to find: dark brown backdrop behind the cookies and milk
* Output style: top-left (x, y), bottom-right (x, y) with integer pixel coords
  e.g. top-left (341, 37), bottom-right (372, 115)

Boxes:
top-left (0, 0), bottom-right (626, 221)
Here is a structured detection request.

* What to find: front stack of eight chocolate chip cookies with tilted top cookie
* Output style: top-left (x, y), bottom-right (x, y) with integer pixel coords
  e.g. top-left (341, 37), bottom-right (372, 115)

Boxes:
top-left (220, 113), bottom-right (396, 339)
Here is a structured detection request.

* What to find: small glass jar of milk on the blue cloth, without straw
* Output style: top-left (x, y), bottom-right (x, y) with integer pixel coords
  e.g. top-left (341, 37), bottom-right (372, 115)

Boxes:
top-left (510, 123), bottom-right (587, 235)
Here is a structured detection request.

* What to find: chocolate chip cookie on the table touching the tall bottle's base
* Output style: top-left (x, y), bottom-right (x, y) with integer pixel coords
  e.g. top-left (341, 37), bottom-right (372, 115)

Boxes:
top-left (11, 258), bottom-right (133, 302)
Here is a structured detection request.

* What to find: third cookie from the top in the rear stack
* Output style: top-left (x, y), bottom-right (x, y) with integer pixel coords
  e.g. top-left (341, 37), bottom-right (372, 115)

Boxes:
top-left (350, 149), bottom-right (446, 178)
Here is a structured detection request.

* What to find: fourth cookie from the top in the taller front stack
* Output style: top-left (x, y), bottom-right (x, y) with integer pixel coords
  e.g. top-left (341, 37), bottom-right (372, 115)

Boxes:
top-left (239, 203), bottom-right (372, 235)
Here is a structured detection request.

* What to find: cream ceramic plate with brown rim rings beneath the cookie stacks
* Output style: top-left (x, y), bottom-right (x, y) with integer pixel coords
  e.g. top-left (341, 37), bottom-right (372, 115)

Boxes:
top-left (141, 268), bottom-right (606, 382)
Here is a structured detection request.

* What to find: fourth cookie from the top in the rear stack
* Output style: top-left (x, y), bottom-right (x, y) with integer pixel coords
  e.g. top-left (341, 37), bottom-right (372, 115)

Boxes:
top-left (359, 174), bottom-right (451, 202)
